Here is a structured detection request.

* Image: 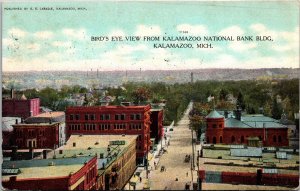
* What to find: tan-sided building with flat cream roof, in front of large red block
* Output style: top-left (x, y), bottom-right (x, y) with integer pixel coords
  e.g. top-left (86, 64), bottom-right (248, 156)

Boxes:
top-left (55, 135), bottom-right (137, 190)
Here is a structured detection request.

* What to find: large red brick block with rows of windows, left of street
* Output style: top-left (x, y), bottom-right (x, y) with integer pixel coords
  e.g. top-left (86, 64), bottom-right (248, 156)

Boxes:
top-left (66, 105), bottom-right (151, 163)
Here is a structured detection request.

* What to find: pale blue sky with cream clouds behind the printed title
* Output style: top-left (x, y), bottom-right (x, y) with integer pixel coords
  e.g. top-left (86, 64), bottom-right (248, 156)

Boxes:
top-left (2, 2), bottom-right (299, 71)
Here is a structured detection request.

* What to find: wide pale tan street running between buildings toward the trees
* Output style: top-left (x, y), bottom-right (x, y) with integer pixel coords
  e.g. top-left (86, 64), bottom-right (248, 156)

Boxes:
top-left (149, 103), bottom-right (197, 190)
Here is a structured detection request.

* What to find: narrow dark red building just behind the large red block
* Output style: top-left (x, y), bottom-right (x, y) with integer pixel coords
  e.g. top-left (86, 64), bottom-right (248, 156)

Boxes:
top-left (150, 109), bottom-right (164, 143)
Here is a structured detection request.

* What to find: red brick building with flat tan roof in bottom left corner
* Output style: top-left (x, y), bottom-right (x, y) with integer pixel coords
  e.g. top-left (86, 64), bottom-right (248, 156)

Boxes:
top-left (2, 156), bottom-right (98, 190)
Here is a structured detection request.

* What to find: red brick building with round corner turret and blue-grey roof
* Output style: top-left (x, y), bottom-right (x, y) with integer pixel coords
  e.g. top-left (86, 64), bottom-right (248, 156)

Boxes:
top-left (205, 110), bottom-right (289, 147)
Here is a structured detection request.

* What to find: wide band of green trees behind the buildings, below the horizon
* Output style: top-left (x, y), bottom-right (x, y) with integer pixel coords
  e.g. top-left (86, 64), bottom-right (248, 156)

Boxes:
top-left (2, 79), bottom-right (299, 124)
